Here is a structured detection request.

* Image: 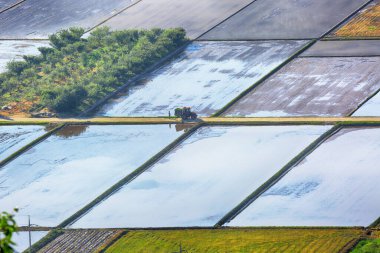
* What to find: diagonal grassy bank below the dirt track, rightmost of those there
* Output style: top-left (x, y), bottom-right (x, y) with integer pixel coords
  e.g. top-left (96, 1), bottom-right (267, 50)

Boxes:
top-left (215, 126), bottom-right (340, 227)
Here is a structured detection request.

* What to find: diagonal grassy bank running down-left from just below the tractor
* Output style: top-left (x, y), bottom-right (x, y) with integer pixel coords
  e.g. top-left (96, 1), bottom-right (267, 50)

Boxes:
top-left (58, 124), bottom-right (202, 228)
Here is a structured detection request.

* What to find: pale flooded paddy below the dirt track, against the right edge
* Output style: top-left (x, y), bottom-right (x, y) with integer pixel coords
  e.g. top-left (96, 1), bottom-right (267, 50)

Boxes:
top-left (227, 128), bottom-right (380, 226)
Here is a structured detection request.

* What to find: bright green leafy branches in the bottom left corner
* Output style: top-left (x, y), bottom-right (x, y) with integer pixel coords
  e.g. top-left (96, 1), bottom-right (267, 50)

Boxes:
top-left (0, 210), bottom-right (17, 253)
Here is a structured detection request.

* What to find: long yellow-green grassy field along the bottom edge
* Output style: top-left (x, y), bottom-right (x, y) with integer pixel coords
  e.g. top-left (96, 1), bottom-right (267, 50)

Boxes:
top-left (106, 228), bottom-right (363, 253)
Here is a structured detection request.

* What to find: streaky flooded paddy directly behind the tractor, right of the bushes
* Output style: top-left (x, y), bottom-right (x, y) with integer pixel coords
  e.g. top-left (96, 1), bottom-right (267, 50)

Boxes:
top-left (99, 41), bottom-right (307, 116)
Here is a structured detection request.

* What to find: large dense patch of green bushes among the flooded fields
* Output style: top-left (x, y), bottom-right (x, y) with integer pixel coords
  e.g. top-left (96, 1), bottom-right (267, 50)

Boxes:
top-left (0, 27), bottom-right (187, 113)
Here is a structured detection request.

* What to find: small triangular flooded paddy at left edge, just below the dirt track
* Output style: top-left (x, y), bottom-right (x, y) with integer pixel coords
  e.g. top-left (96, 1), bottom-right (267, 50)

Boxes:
top-left (0, 126), bottom-right (46, 162)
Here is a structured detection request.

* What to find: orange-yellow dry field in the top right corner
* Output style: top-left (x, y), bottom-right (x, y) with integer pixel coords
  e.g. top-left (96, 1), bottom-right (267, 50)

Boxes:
top-left (335, 4), bottom-right (380, 37)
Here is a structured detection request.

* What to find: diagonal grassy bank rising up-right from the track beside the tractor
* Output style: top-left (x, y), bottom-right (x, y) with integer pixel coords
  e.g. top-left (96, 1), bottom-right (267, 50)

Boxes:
top-left (211, 40), bottom-right (317, 117)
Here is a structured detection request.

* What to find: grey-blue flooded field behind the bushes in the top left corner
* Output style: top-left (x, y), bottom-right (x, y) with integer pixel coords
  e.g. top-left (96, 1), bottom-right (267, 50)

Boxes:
top-left (0, 0), bottom-right (137, 39)
